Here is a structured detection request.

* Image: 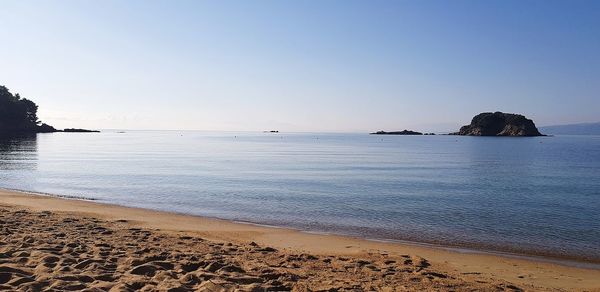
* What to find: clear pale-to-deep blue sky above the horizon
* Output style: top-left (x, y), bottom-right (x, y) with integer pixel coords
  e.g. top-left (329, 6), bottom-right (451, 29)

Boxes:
top-left (0, 0), bottom-right (600, 132)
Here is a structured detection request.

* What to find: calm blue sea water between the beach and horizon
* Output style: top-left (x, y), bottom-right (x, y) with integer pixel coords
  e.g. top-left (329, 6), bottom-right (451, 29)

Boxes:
top-left (0, 131), bottom-right (600, 262)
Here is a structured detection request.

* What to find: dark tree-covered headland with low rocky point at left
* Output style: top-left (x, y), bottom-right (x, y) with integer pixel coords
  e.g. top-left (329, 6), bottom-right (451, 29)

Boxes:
top-left (0, 86), bottom-right (99, 136)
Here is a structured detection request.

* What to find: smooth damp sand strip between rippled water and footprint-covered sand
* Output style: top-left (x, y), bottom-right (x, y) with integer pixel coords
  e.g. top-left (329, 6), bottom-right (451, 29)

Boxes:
top-left (0, 189), bottom-right (600, 291)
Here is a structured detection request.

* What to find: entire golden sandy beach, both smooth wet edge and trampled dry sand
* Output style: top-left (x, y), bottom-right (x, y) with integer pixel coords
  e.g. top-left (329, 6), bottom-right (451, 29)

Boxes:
top-left (0, 190), bottom-right (600, 291)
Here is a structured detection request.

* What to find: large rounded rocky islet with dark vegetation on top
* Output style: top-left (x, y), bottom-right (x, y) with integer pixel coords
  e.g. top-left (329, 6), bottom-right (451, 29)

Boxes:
top-left (452, 112), bottom-right (544, 137)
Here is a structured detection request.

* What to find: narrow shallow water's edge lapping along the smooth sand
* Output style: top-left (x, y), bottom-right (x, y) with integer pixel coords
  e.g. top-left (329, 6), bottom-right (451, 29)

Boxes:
top-left (0, 188), bottom-right (600, 270)
